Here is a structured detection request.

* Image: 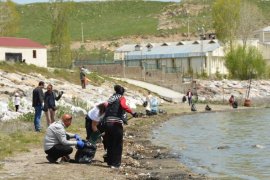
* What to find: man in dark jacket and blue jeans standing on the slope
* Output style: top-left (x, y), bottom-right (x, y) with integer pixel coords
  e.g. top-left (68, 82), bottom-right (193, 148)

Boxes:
top-left (32, 81), bottom-right (44, 132)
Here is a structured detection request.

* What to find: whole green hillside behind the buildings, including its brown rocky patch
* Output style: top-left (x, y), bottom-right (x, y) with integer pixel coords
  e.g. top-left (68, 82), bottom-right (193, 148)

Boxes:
top-left (13, 0), bottom-right (270, 44)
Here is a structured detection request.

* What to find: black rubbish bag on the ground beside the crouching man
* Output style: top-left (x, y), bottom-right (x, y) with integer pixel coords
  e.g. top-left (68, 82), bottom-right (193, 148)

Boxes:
top-left (75, 140), bottom-right (97, 164)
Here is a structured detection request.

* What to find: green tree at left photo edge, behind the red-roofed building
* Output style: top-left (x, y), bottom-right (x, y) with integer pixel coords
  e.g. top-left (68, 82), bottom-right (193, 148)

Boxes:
top-left (0, 0), bottom-right (20, 36)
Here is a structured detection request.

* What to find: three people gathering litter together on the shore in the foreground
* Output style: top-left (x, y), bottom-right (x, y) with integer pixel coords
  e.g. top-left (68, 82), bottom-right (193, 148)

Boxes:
top-left (44, 85), bottom-right (138, 168)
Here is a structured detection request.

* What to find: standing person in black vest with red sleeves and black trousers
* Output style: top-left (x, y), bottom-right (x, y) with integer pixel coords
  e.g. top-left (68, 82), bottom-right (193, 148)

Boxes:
top-left (105, 85), bottom-right (138, 168)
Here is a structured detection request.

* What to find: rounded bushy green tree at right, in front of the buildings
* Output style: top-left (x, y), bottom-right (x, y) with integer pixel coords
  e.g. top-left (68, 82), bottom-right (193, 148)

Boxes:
top-left (225, 46), bottom-right (266, 80)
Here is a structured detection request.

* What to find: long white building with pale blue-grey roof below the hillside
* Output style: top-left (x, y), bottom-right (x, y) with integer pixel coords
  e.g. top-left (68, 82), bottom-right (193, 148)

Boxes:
top-left (114, 40), bottom-right (228, 75)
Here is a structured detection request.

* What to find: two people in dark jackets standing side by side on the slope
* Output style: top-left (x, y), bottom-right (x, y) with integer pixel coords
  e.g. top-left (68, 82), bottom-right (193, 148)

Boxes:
top-left (32, 81), bottom-right (64, 132)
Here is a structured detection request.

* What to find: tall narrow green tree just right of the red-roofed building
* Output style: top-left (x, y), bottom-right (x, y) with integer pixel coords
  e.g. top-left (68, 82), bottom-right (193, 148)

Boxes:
top-left (51, 0), bottom-right (72, 68)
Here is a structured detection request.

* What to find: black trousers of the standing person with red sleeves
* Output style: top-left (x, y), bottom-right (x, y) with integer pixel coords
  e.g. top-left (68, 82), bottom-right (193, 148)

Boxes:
top-left (106, 123), bottom-right (123, 166)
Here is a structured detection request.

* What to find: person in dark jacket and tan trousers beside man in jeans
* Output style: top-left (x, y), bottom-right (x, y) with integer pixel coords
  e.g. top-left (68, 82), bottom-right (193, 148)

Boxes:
top-left (43, 84), bottom-right (63, 126)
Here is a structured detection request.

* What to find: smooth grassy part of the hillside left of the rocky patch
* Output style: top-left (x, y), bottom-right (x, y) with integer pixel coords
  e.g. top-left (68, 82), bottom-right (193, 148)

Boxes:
top-left (17, 1), bottom-right (170, 44)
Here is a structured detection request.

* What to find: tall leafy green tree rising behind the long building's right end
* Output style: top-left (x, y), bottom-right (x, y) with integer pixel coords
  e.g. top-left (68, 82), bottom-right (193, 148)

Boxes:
top-left (212, 0), bottom-right (240, 48)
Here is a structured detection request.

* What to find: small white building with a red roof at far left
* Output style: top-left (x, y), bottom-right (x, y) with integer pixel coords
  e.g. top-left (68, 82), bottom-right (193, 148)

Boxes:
top-left (0, 37), bottom-right (47, 67)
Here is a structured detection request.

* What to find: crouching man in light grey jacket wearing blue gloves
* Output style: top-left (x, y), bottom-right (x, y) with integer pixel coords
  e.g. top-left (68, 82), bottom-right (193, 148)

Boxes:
top-left (44, 114), bottom-right (84, 163)
